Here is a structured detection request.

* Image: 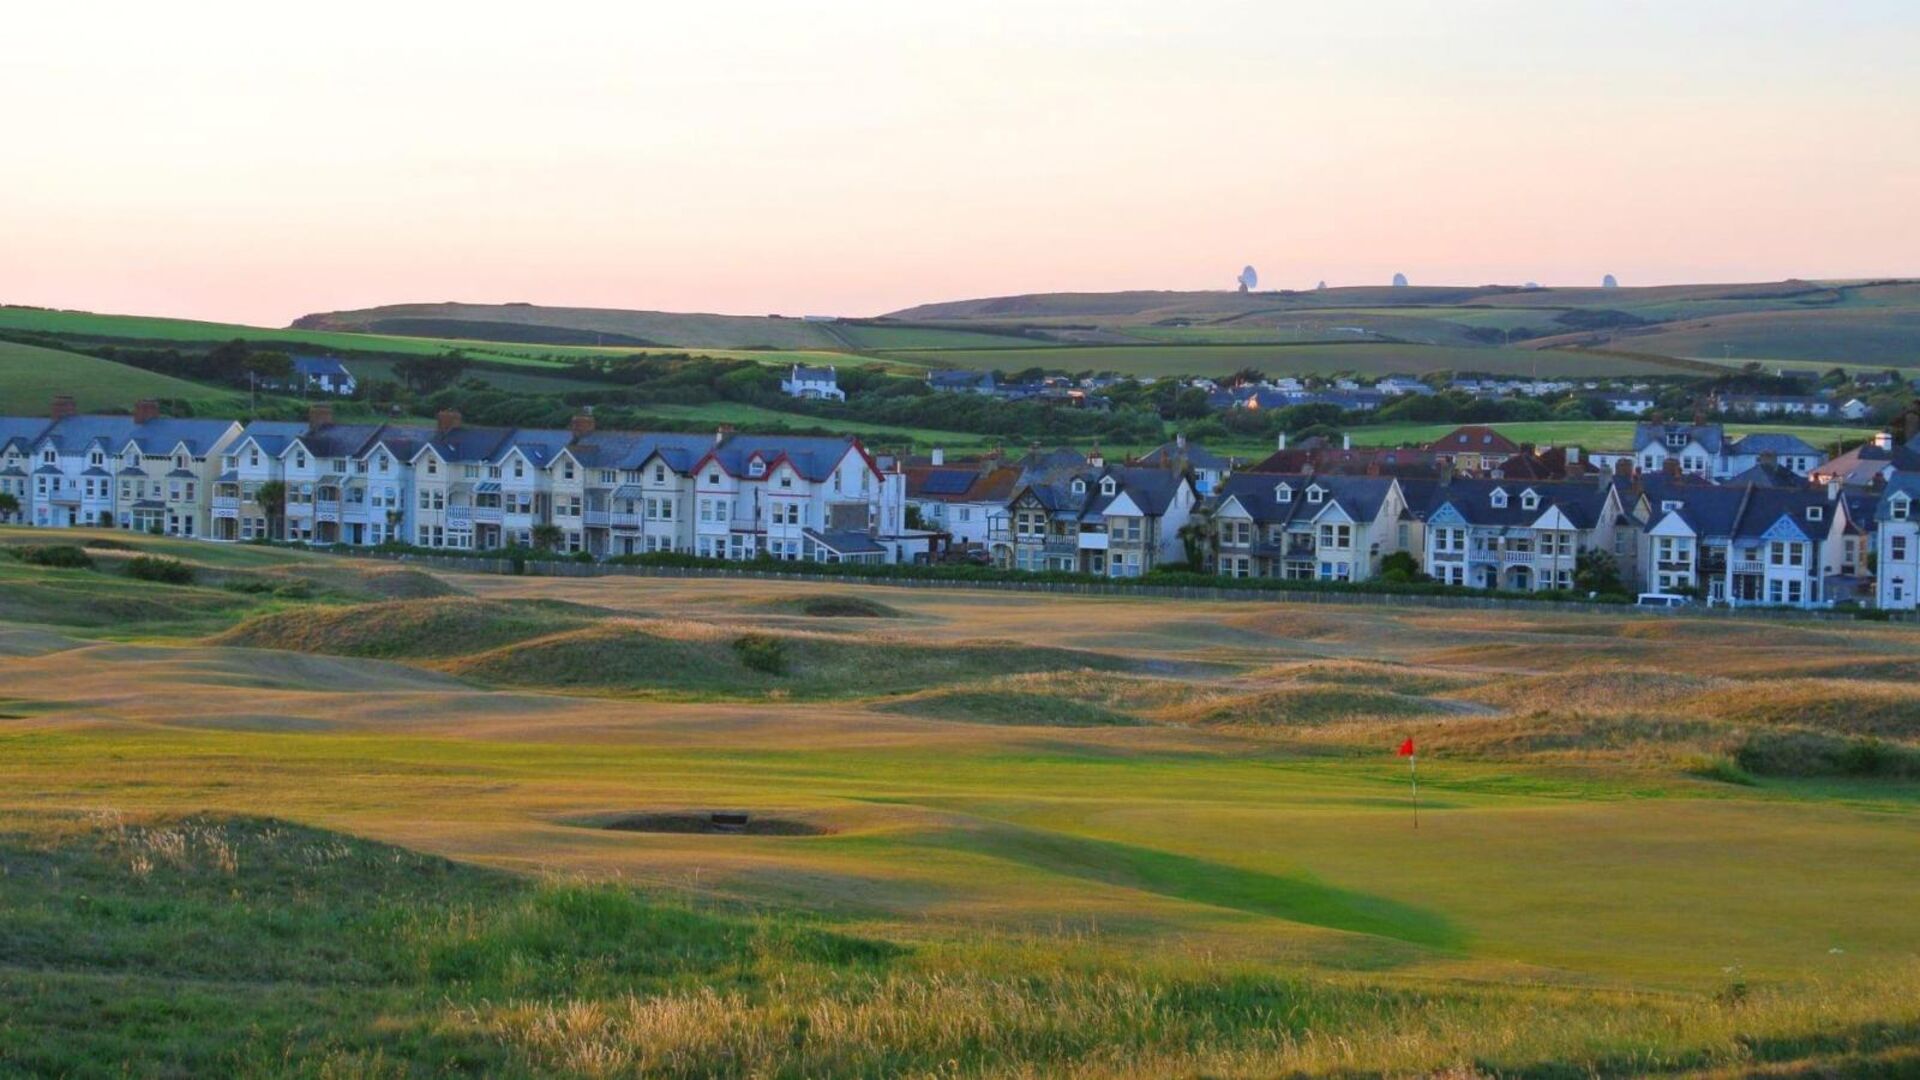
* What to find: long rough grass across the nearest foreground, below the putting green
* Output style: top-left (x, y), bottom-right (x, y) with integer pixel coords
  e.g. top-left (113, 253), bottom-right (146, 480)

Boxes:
top-left (0, 815), bottom-right (1920, 1078)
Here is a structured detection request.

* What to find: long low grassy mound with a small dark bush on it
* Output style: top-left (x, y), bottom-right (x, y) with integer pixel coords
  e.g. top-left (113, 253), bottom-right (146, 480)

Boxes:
top-left (445, 621), bottom-right (1117, 696)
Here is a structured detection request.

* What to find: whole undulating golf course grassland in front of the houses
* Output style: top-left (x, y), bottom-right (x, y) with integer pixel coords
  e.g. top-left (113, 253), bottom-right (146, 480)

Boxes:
top-left (0, 530), bottom-right (1920, 1076)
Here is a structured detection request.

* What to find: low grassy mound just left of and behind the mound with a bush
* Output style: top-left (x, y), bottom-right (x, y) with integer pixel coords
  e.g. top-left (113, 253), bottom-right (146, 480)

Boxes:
top-left (211, 598), bottom-right (593, 659)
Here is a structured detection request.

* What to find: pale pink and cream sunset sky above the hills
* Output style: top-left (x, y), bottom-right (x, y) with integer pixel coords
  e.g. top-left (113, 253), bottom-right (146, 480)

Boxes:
top-left (0, 0), bottom-right (1920, 325)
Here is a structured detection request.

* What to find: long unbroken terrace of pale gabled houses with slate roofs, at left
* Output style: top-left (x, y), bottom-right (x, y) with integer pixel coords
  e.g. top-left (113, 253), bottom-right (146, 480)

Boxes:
top-left (0, 398), bottom-right (927, 563)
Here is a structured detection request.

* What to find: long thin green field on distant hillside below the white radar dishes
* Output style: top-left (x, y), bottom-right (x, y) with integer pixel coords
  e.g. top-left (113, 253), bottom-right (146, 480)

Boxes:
top-left (883, 344), bottom-right (1680, 377)
